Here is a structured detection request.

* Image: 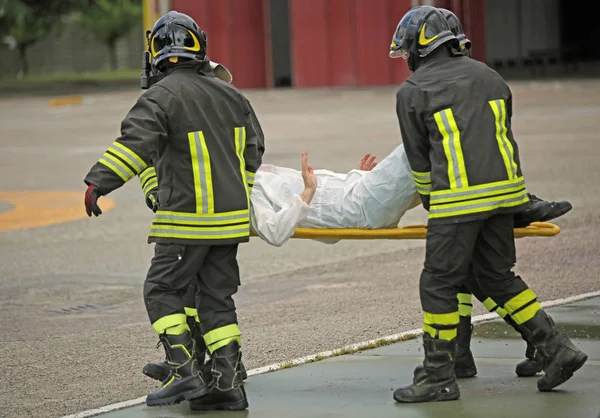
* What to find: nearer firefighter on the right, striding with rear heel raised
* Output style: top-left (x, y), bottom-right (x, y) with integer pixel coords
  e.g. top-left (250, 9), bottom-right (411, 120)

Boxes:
top-left (390, 6), bottom-right (587, 402)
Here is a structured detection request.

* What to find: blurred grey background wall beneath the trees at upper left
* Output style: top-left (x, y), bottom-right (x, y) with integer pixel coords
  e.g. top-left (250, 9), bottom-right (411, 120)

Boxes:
top-left (0, 18), bottom-right (144, 77)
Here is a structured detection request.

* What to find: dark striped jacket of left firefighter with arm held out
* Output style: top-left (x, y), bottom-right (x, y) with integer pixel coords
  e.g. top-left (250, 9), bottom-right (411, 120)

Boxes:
top-left (85, 62), bottom-right (264, 245)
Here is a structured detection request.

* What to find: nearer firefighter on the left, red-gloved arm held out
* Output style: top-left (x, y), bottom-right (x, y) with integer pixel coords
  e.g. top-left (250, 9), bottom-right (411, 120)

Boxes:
top-left (85, 11), bottom-right (264, 410)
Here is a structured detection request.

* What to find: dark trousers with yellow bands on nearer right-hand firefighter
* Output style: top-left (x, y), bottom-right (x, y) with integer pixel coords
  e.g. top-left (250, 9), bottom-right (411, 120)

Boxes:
top-left (419, 215), bottom-right (541, 340)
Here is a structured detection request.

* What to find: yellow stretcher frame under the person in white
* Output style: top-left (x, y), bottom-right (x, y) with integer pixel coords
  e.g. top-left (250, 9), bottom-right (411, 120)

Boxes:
top-left (251, 222), bottom-right (560, 240)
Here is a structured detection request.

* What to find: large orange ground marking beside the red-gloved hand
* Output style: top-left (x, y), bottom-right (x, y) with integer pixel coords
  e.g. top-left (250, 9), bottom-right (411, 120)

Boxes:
top-left (0, 190), bottom-right (116, 231)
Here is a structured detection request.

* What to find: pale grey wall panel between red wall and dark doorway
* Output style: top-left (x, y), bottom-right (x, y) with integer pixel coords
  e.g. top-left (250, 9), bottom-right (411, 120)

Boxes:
top-left (486, 0), bottom-right (560, 62)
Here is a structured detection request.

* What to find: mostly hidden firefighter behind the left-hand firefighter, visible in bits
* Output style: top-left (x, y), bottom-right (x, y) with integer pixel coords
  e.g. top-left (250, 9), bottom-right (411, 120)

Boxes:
top-left (138, 62), bottom-right (251, 382)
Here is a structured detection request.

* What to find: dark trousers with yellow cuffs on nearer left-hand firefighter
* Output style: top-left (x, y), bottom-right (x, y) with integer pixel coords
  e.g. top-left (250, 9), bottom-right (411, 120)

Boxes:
top-left (144, 244), bottom-right (241, 353)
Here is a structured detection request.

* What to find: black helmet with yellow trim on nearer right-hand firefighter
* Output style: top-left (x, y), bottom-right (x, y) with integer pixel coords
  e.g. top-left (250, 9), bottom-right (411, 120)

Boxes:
top-left (390, 6), bottom-right (458, 59)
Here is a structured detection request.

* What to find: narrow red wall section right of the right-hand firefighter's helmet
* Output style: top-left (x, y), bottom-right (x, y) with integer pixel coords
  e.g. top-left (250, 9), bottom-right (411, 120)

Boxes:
top-left (435, 0), bottom-right (486, 62)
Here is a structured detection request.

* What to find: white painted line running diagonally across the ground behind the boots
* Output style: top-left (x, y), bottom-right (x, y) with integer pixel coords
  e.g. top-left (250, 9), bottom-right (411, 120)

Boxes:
top-left (61, 291), bottom-right (600, 418)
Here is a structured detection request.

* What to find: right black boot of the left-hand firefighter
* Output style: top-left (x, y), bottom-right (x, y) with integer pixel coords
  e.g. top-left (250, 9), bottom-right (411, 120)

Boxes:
top-left (190, 341), bottom-right (248, 411)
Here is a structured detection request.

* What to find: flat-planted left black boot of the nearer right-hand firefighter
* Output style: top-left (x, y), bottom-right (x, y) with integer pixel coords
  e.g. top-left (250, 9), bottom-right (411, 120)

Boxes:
top-left (394, 334), bottom-right (460, 403)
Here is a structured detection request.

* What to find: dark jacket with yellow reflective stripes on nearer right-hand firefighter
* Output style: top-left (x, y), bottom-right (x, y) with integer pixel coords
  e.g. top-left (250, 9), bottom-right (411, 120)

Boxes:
top-left (396, 49), bottom-right (529, 224)
